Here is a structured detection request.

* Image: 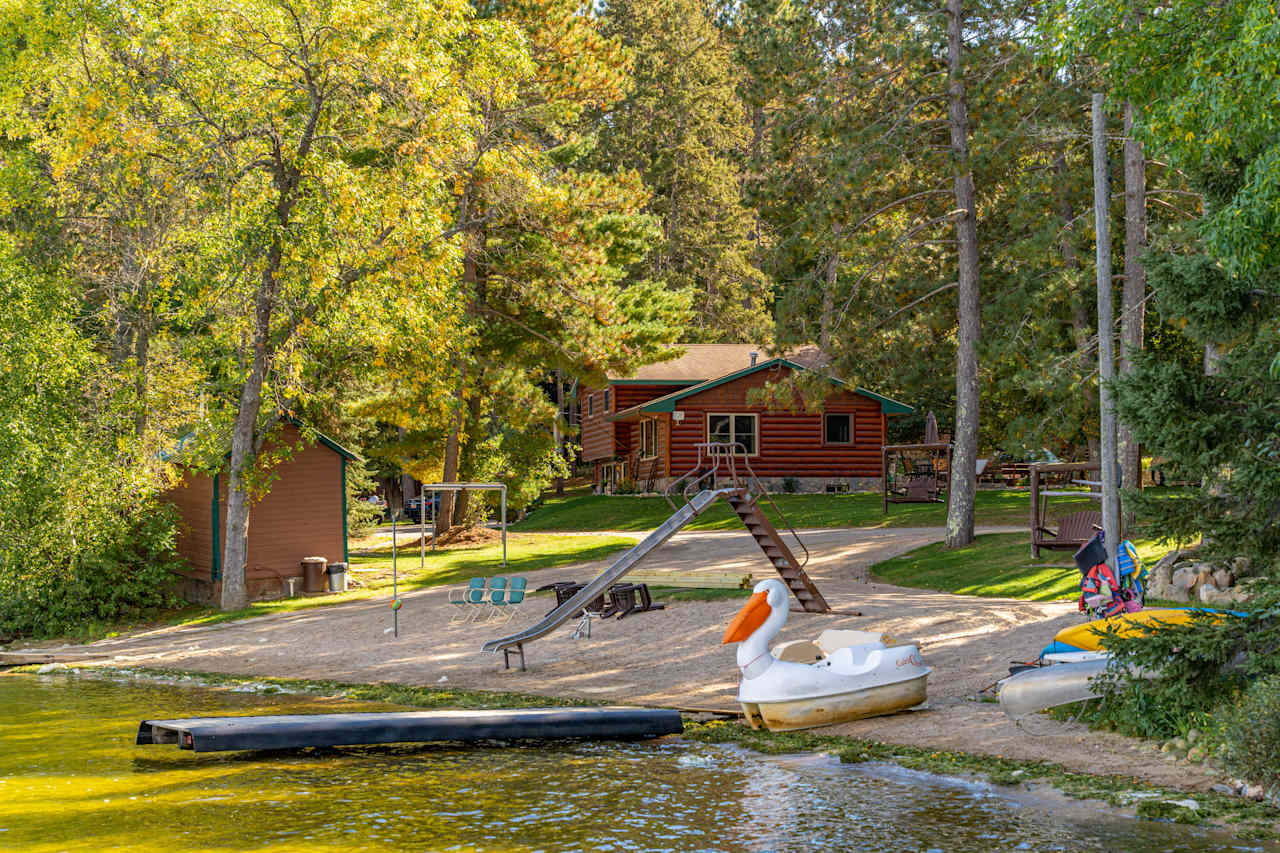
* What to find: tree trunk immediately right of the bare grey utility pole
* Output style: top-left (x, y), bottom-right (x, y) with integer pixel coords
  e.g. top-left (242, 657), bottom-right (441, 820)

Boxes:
top-left (1119, 101), bottom-right (1147, 488)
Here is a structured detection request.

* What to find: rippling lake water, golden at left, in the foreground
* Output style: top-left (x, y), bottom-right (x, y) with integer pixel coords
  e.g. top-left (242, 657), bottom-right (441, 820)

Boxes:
top-left (0, 675), bottom-right (1270, 853)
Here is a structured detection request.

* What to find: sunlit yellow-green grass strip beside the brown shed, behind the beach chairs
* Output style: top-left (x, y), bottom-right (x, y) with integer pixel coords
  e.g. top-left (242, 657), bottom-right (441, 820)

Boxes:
top-left (166, 533), bottom-right (635, 625)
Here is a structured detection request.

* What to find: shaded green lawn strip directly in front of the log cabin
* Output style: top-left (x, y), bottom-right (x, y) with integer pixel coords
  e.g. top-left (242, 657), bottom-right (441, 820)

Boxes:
top-left (512, 489), bottom-right (1097, 530)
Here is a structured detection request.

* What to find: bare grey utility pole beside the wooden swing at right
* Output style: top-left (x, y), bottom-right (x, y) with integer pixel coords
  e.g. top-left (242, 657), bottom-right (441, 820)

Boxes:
top-left (1093, 93), bottom-right (1120, 566)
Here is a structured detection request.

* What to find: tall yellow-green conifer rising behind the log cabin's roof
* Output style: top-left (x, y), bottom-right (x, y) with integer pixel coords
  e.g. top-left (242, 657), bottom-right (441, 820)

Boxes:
top-left (591, 0), bottom-right (772, 342)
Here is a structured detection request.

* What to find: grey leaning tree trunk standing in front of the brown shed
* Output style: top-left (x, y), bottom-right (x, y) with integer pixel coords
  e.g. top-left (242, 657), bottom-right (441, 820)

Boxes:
top-left (214, 279), bottom-right (272, 610)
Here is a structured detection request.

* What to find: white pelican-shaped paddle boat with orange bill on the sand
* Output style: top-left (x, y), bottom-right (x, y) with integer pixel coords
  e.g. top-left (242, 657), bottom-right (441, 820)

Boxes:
top-left (722, 578), bottom-right (932, 731)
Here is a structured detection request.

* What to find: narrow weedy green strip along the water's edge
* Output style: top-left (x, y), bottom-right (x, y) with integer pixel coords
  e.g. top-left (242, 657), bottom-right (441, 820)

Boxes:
top-left (12, 662), bottom-right (1280, 841)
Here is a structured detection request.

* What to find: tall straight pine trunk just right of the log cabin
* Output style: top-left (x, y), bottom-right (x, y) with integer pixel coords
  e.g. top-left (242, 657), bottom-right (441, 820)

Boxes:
top-left (946, 0), bottom-right (982, 548)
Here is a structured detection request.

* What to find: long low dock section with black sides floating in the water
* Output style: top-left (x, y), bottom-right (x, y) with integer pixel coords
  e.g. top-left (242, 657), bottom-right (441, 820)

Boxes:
top-left (137, 708), bottom-right (685, 752)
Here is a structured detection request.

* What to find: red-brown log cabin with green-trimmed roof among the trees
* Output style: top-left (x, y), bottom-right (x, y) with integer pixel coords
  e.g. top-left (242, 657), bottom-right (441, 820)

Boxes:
top-left (579, 343), bottom-right (913, 493)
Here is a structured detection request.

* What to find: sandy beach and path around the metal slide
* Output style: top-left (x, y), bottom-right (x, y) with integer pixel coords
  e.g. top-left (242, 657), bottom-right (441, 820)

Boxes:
top-left (49, 528), bottom-right (1215, 789)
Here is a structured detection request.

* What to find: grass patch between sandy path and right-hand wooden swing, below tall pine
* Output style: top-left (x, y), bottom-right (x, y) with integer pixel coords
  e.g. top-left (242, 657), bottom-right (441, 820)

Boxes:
top-left (872, 533), bottom-right (1171, 601)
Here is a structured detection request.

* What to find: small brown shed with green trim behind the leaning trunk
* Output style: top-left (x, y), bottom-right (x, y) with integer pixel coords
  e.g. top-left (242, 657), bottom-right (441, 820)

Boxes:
top-left (165, 423), bottom-right (360, 602)
